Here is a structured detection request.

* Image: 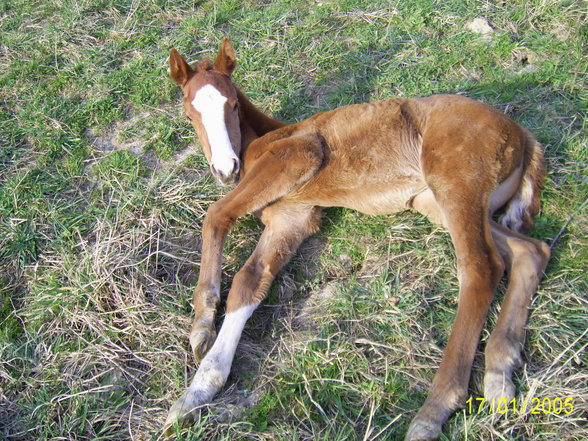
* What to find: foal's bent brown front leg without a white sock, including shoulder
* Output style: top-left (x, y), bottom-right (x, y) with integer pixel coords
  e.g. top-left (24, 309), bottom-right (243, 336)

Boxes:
top-left (190, 135), bottom-right (323, 361)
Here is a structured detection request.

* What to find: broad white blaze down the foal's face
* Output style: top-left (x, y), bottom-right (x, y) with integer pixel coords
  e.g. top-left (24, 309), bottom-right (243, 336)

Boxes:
top-left (192, 84), bottom-right (239, 176)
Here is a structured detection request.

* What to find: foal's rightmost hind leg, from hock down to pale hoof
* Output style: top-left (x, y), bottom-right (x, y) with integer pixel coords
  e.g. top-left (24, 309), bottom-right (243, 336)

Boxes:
top-left (484, 222), bottom-right (550, 401)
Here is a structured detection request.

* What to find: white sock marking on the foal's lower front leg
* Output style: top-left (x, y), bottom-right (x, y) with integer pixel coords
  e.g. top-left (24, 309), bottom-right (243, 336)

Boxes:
top-left (188, 303), bottom-right (259, 400)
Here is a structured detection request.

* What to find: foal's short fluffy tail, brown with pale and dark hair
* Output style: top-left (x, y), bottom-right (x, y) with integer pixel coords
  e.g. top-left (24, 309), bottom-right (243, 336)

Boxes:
top-left (500, 130), bottom-right (546, 233)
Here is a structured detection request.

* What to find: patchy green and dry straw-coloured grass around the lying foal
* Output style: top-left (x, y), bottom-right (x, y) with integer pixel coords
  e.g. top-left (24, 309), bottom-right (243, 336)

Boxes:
top-left (0, 0), bottom-right (588, 441)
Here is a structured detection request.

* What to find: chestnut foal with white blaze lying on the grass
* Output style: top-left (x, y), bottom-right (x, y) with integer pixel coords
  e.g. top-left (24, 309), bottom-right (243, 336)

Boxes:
top-left (166, 39), bottom-right (549, 441)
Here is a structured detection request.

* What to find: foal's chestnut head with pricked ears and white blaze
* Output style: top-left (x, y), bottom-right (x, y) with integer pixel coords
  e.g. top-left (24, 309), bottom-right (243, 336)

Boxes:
top-left (169, 38), bottom-right (241, 184)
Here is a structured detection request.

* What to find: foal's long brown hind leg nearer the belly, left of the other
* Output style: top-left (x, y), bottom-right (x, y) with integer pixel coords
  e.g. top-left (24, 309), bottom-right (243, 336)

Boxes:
top-left (406, 192), bottom-right (504, 441)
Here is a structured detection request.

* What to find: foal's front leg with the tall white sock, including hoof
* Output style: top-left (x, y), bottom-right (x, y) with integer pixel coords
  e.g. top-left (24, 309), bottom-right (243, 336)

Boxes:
top-left (164, 204), bottom-right (320, 432)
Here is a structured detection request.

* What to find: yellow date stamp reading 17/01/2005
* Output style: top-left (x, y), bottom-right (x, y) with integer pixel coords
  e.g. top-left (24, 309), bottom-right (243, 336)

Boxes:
top-left (465, 397), bottom-right (574, 415)
